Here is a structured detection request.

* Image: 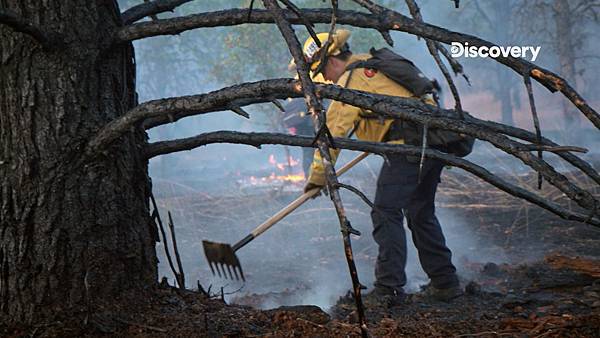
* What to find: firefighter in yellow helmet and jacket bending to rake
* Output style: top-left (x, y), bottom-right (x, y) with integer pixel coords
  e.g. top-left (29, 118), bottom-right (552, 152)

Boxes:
top-left (303, 29), bottom-right (462, 305)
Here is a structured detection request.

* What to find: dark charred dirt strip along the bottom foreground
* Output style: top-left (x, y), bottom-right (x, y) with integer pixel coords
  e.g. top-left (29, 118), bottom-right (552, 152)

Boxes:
top-left (0, 255), bottom-right (600, 337)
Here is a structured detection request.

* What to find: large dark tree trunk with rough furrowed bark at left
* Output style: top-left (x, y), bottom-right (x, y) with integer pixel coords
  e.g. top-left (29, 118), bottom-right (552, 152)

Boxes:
top-left (0, 0), bottom-right (157, 323)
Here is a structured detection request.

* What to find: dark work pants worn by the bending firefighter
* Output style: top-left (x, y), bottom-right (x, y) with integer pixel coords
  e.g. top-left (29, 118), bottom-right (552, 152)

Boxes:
top-left (371, 155), bottom-right (458, 291)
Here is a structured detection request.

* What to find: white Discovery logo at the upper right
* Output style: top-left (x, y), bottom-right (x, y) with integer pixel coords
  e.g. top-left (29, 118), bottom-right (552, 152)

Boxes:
top-left (450, 42), bottom-right (542, 62)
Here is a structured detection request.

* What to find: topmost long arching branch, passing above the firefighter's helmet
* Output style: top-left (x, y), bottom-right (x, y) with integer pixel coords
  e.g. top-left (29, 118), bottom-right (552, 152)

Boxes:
top-left (116, 9), bottom-right (600, 129)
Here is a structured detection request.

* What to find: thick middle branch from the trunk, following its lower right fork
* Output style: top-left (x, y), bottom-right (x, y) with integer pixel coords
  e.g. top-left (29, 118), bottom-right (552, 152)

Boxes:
top-left (86, 77), bottom-right (600, 219)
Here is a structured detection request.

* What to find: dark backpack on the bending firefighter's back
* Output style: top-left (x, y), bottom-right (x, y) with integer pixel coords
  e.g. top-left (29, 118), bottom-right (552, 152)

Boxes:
top-left (346, 48), bottom-right (475, 157)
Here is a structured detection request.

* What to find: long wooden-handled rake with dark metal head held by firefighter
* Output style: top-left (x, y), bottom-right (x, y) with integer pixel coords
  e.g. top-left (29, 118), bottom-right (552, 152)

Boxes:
top-left (202, 153), bottom-right (369, 281)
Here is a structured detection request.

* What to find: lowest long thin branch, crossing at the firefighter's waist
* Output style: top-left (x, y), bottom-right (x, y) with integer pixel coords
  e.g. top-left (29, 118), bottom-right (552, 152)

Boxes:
top-left (144, 131), bottom-right (600, 227)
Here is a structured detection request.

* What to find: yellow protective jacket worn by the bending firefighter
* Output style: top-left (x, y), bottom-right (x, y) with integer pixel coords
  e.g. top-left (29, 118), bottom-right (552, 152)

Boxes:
top-left (308, 54), bottom-right (435, 186)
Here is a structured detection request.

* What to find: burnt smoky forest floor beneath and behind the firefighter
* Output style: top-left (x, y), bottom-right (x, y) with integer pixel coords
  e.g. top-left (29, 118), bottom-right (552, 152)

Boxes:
top-left (0, 154), bottom-right (600, 337)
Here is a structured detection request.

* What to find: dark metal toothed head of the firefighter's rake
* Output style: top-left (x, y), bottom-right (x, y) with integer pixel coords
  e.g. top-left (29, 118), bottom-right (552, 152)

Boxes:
top-left (202, 241), bottom-right (246, 281)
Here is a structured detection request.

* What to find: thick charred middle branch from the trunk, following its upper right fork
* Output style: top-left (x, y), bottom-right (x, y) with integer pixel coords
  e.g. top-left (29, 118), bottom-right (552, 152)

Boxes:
top-left (87, 79), bottom-right (600, 190)
